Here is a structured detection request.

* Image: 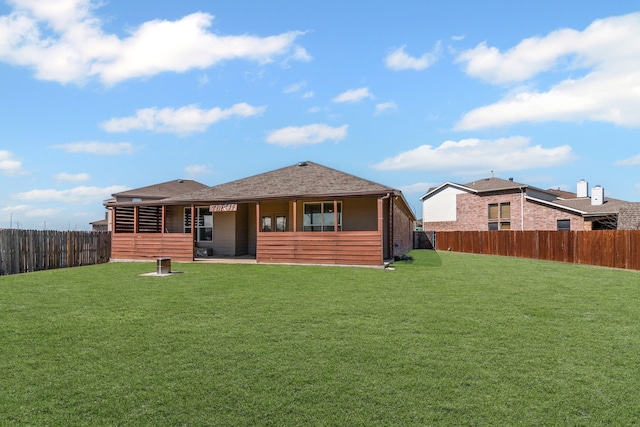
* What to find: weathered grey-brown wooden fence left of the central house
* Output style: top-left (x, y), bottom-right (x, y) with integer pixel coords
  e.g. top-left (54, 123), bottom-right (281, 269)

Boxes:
top-left (0, 229), bottom-right (111, 275)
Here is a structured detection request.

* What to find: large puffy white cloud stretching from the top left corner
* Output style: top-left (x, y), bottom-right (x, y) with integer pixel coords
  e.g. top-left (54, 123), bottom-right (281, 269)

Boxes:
top-left (0, 0), bottom-right (311, 84)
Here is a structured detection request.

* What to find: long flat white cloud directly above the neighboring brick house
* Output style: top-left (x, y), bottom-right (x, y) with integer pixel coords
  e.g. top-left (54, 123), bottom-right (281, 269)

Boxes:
top-left (374, 136), bottom-right (573, 174)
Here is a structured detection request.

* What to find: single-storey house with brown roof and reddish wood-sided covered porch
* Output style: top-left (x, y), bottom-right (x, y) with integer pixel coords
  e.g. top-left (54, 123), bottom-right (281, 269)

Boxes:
top-left (109, 162), bottom-right (416, 265)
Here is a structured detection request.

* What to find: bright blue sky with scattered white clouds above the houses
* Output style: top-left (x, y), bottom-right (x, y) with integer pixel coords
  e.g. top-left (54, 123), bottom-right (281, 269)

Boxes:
top-left (0, 0), bottom-right (640, 230)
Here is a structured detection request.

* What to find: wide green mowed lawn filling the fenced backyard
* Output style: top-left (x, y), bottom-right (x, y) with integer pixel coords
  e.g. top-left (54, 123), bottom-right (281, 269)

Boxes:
top-left (0, 251), bottom-right (640, 426)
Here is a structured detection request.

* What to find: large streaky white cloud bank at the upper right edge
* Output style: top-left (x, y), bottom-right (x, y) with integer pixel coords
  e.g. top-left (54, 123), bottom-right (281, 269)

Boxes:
top-left (456, 13), bottom-right (640, 130)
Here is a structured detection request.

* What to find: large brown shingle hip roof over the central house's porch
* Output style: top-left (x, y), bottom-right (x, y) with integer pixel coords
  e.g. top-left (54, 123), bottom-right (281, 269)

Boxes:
top-left (163, 162), bottom-right (401, 203)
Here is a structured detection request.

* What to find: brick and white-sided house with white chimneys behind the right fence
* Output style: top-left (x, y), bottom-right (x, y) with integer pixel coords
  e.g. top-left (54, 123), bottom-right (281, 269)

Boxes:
top-left (420, 178), bottom-right (640, 231)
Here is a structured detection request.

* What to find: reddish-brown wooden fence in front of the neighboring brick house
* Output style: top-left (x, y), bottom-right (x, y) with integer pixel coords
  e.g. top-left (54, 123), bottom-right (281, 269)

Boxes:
top-left (435, 230), bottom-right (640, 270)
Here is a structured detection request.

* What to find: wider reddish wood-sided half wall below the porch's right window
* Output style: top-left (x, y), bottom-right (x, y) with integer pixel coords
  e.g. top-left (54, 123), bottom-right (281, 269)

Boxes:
top-left (256, 231), bottom-right (383, 265)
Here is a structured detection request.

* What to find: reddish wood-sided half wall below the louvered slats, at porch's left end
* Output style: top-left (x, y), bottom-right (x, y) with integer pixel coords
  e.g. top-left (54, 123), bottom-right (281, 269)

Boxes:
top-left (111, 233), bottom-right (193, 261)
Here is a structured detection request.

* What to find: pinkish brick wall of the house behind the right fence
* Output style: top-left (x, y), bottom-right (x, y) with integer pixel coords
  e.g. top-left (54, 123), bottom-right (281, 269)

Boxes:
top-left (423, 190), bottom-right (590, 231)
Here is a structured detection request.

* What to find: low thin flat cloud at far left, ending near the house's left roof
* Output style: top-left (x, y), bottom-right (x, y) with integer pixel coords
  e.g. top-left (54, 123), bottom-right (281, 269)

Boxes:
top-left (13, 185), bottom-right (129, 205)
